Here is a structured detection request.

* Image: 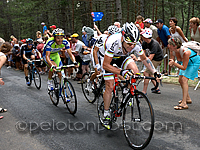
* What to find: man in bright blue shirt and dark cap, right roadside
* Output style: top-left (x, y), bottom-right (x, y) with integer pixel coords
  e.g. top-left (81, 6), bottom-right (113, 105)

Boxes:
top-left (155, 19), bottom-right (171, 75)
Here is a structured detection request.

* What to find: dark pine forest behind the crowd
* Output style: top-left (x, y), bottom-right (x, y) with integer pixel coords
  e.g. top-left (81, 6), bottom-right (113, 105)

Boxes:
top-left (0, 0), bottom-right (200, 41)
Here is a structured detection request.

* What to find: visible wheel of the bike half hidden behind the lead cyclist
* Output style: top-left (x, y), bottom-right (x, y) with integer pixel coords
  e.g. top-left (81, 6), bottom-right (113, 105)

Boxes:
top-left (81, 73), bottom-right (96, 103)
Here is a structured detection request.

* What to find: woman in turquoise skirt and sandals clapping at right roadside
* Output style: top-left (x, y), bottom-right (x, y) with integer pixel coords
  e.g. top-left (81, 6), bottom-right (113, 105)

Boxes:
top-left (168, 37), bottom-right (200, 110)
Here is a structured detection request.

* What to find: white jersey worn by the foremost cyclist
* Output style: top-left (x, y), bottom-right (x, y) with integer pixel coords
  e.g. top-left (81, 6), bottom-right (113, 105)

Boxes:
top-left (105, 33), bottom-right (144, 58)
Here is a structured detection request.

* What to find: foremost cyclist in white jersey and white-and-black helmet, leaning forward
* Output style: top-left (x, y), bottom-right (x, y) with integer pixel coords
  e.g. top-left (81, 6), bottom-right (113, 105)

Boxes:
top-left (103, 22), bottom-right (157, 129)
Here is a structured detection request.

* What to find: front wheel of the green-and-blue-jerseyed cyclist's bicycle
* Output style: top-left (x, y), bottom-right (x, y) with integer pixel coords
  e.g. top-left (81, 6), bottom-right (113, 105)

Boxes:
top-left (62, 79), bottom-right (77, 114)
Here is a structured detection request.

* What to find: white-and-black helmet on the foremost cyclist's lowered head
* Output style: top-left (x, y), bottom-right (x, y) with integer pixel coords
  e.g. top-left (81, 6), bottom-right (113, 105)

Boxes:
top-left (122, 22), bottom-right (140, 43)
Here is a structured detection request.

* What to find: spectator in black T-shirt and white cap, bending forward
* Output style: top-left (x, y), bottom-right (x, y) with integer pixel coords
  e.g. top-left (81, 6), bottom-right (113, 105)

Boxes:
top-left (139, 29), bottom-right (164, 97)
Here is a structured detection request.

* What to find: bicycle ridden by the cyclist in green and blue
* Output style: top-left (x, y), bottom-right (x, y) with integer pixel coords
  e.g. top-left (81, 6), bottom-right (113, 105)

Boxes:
top-left (48, 64), bottom-right (77, 115)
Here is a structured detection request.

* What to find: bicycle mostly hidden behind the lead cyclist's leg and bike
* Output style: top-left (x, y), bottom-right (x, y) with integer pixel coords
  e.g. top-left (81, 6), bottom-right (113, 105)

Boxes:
top-left (81, 71), bottom-right (105, 103)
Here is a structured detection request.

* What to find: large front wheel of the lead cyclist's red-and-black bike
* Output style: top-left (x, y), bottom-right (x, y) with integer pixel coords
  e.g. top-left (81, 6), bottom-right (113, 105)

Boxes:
top-left (123, 91), bottom-right (154, 149)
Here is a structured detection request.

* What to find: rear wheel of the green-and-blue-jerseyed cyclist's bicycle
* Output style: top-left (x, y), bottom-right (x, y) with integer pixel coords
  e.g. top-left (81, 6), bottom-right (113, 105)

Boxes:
top-left (48, 76), bottom-right (59, 106)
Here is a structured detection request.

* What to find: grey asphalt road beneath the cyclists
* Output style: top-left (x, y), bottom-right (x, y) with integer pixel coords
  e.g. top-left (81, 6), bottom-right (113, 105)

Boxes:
top-left (0, 67), bottom-right (200, 150)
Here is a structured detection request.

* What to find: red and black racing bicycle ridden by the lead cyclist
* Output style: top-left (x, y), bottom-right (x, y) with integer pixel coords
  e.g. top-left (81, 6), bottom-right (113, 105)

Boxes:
top-left (97, 75), bottom-right (158, 149)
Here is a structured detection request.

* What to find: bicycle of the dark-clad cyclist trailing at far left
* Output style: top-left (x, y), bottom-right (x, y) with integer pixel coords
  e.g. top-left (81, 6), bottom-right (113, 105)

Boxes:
top-left (27, 60), bottom-right (41, 90)
